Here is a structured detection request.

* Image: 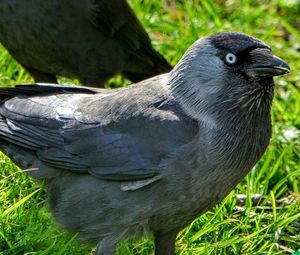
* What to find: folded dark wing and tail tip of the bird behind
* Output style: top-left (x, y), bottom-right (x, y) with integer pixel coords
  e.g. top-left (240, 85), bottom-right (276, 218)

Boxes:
top-left (88, 0), bottom-right (172, 82)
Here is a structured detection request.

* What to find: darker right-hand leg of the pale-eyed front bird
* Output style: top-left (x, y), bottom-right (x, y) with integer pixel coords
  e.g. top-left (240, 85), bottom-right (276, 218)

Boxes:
top-left (154, 230), bottom-right (178, 255)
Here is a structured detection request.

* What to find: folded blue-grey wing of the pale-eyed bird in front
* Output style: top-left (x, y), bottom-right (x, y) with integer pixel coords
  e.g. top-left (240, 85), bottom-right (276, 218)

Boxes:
top-left (0, 83), bottom-right (197, 180)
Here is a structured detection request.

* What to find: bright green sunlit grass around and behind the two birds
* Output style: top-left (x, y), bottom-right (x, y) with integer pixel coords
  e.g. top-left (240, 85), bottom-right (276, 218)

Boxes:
top-left (0, 0), bottom-right (300, 255)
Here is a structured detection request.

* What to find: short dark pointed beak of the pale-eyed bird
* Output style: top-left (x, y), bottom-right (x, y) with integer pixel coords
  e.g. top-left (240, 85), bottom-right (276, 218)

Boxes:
top-left (246, 49), bottom-right (290, 76)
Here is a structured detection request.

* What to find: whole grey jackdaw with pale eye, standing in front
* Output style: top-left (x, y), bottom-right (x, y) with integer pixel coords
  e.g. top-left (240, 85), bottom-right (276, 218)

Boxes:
top-left (0, 33), bottom-right (289, 255)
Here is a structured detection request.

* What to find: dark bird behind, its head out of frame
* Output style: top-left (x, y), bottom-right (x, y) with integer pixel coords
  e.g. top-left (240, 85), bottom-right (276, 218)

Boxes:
top-left (0, 0), bottom-right (172, 86)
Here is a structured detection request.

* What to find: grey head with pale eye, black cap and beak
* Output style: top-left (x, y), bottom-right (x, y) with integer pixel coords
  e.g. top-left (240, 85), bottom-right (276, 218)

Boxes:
top-left (169, 32), bottom-right (290, 124)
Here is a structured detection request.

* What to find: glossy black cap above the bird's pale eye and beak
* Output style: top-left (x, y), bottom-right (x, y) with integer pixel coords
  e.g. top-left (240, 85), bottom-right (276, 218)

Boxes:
top-left (210, 32), bottom-right (271, 54)
